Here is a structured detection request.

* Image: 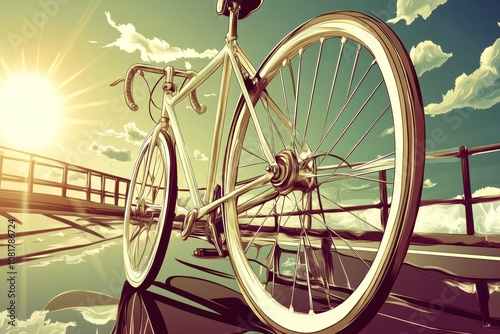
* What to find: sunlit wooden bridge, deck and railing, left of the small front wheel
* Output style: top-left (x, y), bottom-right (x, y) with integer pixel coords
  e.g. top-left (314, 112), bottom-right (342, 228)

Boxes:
top-left (0, 146), bottom-right (130, 215)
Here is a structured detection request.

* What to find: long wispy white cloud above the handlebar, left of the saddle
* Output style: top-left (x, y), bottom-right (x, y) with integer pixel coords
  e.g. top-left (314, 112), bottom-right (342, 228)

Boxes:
top-left (105, 12), bottom-right (217, 63)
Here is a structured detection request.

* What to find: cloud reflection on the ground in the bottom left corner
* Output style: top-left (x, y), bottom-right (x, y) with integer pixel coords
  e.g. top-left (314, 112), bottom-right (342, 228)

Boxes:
top-left (0, 311), bottom-right (76, 334)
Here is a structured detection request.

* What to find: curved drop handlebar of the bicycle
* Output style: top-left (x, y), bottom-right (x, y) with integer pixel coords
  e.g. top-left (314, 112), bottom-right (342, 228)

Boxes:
top-left (111, 64), bottom-right (207, 115)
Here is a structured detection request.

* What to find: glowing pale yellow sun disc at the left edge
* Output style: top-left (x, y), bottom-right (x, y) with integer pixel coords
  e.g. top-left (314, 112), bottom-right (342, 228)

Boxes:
top-left (0, 74), bottom-right (61, 149)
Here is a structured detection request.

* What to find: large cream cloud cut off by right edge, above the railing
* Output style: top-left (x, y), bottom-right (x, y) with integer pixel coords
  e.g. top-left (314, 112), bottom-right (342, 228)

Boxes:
top-left (424, 38), bottom-right (500, 116)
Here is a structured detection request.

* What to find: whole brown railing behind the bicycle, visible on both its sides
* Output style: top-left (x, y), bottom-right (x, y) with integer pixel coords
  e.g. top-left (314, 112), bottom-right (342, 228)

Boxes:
top-left (0, 143), bottom-right (500, 235)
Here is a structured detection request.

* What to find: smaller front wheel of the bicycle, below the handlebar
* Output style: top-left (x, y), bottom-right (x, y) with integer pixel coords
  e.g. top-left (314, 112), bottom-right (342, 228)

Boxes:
top-left (123, 132), bottom-right (177, 288)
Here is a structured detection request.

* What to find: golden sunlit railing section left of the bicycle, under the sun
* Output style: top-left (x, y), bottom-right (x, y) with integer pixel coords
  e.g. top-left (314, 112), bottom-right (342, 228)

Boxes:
top-left (0, 146), bottom-right (130, 206)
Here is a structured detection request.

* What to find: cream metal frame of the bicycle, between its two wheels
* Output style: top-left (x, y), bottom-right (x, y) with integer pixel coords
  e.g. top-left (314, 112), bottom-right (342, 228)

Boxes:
top-left (147, 7), bottom-right (276, 228)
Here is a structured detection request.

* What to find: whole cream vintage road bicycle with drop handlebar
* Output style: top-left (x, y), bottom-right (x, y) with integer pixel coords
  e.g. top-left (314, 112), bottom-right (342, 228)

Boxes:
top-left (114, 0), bottom-right (425, 333)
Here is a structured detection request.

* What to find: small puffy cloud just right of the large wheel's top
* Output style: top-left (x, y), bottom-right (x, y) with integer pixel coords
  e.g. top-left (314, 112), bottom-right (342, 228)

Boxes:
top-left (410, 41), bottom-right (453, 76)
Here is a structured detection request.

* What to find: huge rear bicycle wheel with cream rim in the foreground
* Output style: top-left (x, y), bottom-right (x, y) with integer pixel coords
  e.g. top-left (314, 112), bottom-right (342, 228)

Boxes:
top-left (224, 12), bottom-right (425, 333)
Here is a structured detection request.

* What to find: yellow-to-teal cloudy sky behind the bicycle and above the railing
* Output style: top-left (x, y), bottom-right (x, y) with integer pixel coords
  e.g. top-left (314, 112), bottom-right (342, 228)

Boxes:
top-left (0, 0), bottom-right (500, 232)
